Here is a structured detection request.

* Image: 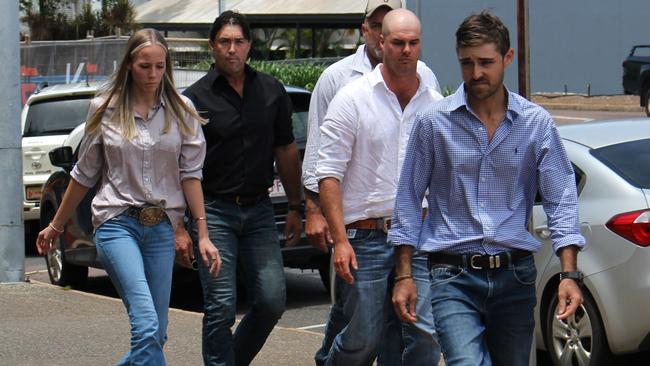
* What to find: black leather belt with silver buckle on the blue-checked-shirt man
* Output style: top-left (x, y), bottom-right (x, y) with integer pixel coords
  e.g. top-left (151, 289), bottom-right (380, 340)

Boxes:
top-left (429, 249), bottom-right (533, 270)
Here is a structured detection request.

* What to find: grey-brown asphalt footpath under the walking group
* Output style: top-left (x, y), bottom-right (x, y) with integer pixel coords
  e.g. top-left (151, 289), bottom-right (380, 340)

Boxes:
top-left (0, 282), bottom-right (322, 366)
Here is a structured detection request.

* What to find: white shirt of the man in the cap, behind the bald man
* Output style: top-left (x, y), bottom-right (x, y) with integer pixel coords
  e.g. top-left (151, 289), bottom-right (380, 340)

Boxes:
top-left (302, 45), bottom-right (440, 192)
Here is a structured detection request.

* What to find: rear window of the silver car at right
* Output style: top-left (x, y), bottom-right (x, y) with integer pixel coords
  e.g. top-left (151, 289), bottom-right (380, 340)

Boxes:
top-left (591, 139), bottom-right (650, 189)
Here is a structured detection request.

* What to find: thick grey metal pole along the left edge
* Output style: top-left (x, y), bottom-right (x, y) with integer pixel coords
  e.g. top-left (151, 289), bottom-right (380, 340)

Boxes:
top-left (0, 0), bottom-right (25, 282)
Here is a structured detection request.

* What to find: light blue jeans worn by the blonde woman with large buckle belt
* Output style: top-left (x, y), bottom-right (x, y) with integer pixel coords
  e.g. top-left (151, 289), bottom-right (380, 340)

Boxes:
top-left (95, 214), bottom-right (175, 365)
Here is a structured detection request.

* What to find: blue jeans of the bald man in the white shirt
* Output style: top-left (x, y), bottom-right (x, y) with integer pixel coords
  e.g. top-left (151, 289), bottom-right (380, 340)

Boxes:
top-left (315, 230), bottom-right (440, 365)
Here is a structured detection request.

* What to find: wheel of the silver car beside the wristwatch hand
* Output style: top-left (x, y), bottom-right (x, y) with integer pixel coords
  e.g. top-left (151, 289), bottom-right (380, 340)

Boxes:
top-left (544, 291), bottom-right (611, 366)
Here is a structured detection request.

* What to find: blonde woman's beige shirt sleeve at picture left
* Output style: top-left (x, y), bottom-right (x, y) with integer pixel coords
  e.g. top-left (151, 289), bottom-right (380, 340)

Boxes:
top-left (70, 98), bottom-right (104, 188)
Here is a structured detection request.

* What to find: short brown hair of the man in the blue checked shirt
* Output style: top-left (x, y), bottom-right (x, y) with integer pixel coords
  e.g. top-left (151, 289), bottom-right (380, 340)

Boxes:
top-left (456, 10), bottom-right (510, 56)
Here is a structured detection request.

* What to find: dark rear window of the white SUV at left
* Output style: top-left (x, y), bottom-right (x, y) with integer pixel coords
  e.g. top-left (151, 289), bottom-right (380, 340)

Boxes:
top-left (24, 95), bottom-right (92, 137)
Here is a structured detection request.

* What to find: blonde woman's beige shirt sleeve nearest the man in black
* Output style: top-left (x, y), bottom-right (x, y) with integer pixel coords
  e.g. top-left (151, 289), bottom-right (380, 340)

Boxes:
top-left (178, 97), bottom-right (206, 182)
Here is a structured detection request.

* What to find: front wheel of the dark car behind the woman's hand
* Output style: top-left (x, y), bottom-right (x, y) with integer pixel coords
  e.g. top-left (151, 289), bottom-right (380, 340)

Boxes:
top-left (45, 213), bottom-right (88, 288)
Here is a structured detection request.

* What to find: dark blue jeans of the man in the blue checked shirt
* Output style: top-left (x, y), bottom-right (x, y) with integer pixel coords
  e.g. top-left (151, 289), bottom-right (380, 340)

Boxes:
top-left (430, 256), bottom-right (537, 366)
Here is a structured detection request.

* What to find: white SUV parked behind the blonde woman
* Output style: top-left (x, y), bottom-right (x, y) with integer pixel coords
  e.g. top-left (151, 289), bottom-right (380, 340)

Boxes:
top-left (21, 83), bottom-right (97, 225)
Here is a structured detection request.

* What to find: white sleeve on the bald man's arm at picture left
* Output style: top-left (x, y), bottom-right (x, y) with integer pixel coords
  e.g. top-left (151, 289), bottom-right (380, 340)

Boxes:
top-left (316, 89), bottom-right (359, 181)
